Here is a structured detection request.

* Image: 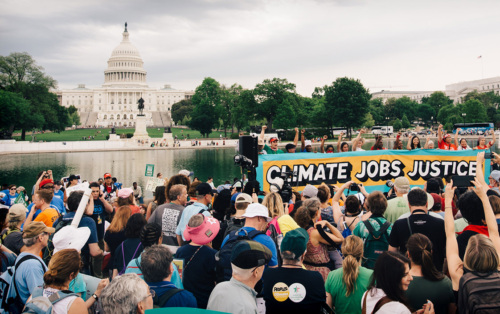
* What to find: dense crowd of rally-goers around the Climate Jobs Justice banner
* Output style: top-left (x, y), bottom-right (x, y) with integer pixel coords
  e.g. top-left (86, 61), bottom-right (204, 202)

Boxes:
top-left (0, 141), bottom-right (500, 313)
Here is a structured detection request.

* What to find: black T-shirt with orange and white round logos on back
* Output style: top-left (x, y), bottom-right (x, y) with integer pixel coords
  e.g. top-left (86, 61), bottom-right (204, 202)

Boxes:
top-left (262, 267), bottom-right (326, 314)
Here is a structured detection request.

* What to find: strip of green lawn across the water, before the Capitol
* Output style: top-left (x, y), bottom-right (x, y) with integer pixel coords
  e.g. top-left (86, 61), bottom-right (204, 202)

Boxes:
top-left (13, 128), bottom-right (230, 142)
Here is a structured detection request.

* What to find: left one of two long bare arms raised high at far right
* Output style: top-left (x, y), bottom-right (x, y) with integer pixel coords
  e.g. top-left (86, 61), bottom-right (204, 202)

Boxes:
top-left (444, 182), bottom-right (464, 291)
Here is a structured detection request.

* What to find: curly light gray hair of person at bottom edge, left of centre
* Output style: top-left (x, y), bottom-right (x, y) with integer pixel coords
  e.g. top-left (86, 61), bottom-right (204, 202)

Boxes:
top-left (100, 273), bottom-right (149, 314)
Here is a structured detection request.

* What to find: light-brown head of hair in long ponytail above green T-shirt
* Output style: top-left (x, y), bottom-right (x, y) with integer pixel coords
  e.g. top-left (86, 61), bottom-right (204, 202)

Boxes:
top-left (342, 235), bottom-right (363, 297)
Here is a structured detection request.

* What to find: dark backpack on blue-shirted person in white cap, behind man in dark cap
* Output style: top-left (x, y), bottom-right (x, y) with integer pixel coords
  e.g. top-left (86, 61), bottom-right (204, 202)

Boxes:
top-left (215, 229), bottom-right (265, 283)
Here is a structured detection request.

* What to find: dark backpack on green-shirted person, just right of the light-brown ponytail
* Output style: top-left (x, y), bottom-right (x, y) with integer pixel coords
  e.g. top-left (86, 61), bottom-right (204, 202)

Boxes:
top-left (362, 218), bottom-right (391, 269)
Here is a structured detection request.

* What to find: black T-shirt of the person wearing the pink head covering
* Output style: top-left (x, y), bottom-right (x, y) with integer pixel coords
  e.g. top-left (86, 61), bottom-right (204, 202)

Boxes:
top-left (175, 244), bottom-right (217, 309)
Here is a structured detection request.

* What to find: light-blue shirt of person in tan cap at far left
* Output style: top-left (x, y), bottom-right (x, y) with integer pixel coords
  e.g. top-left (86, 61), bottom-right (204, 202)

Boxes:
top-left (10, 252), bottom-right (47, 303)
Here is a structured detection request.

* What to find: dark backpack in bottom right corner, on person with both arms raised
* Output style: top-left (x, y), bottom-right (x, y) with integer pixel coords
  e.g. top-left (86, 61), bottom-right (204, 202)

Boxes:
top-left (457, 271), bottom-right (500, 314)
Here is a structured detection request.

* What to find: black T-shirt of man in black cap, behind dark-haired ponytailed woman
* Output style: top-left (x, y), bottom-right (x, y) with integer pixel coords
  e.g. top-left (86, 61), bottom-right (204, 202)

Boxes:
top-left (389, 214), bottom-right (446, 271)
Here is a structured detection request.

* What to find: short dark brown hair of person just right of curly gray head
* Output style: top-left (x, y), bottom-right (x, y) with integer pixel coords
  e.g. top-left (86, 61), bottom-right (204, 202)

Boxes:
top-left (141, 244), bottom-right (173, 282)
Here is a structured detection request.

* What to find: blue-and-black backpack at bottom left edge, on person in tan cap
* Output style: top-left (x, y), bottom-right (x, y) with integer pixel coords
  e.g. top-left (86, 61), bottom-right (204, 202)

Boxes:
top-left (0, 254), bottom-right (47, 314)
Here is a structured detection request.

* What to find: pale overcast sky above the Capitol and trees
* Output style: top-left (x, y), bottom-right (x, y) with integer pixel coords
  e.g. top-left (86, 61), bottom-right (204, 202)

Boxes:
top-left (0, 0), bottom-right (500, 96)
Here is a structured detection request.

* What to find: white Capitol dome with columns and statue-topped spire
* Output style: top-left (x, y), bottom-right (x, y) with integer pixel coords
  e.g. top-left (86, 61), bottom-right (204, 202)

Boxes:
top-left (103, 23), bottom-right (147, 87)
